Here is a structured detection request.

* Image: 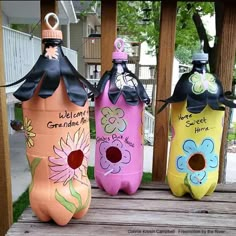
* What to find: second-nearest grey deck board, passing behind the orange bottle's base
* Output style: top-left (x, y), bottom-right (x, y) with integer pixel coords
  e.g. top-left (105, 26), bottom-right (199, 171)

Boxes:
top-left (19, 209), bottom-right (236, 229)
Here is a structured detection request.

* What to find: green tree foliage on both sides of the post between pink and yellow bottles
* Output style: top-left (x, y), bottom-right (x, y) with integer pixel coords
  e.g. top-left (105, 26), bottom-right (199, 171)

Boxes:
top-left (118, 1), bottom-right (214, 66)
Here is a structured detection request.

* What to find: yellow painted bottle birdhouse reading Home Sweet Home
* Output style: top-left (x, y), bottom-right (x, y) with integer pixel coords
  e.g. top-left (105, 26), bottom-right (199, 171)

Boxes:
top-left (161, 49), bottom-right (236, 199)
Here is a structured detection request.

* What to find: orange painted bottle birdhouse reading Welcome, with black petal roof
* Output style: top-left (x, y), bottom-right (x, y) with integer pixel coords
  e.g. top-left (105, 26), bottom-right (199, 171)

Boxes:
top-left (10, 13), bottom-right (97, 225)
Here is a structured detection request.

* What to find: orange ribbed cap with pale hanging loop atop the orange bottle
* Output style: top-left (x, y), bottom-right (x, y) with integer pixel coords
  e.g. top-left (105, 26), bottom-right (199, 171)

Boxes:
top-left (42, 12), bottom-right (62, 39)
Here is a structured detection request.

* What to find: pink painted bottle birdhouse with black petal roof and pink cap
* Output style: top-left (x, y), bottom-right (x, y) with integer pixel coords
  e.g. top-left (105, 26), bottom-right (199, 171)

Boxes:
top-left (95, 39), bottom-right (149, 195)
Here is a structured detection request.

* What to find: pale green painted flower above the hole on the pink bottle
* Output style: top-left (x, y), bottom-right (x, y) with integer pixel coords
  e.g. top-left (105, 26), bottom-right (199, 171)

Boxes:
top-left (101, 107), bottom-right (127, 134)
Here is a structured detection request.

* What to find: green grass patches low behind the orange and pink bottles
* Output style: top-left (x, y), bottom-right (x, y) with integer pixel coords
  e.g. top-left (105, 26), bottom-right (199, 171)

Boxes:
top-left (13, 166), bottom-right (152, 222)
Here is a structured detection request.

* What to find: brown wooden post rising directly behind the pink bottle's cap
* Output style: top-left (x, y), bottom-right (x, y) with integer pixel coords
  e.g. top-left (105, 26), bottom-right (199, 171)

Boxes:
top-left (101, 0), bottom-right (117, 74)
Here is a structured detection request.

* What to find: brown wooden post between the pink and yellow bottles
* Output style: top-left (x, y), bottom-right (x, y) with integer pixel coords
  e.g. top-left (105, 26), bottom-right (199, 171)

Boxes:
top-left (152, 0), bottom-right (177, 182)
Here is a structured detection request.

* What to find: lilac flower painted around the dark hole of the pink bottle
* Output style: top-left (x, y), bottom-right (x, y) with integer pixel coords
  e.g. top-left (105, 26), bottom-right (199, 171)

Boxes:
top-left (99, 139), bottom-right (131, 175)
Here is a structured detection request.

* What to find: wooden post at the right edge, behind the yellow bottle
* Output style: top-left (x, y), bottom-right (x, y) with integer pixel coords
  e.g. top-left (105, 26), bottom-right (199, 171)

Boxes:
top-left (216, 1), bottom-right (236, 183)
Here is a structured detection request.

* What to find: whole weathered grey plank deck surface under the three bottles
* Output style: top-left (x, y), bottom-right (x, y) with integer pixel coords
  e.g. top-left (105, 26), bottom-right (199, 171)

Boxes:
top-left (7, 182), bottom-right (236, 236)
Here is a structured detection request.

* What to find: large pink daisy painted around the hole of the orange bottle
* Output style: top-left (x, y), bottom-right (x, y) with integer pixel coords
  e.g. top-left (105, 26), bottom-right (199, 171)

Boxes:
top-left (48, 129), bottom-right (90, 185)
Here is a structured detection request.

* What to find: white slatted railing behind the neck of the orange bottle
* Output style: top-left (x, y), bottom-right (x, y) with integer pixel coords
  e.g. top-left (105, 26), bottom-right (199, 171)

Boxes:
top-left (3, 26), bottom-right (77, 93)
